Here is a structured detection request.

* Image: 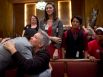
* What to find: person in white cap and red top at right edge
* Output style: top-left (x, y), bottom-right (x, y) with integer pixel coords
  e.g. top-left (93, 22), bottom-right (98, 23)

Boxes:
top-left (88, 27), bottom-right (103, 61)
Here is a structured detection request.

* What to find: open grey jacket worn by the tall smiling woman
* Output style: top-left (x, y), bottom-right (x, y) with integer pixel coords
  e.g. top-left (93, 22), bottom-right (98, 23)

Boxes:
top-left (39, 19), bottom-right (63, 48)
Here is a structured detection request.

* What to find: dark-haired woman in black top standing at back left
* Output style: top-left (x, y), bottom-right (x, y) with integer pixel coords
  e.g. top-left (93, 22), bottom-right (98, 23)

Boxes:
top-left (22, 15), bottom-right (39, 39)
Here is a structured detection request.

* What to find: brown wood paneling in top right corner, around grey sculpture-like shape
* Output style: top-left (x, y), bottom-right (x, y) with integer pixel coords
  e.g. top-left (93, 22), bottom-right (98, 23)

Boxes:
top-left (85, 0), bottom-right (103, 26)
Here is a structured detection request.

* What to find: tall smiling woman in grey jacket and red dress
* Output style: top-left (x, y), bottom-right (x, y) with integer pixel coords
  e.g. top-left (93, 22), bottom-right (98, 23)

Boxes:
top-left (39, 3), bottom-right (63, 59)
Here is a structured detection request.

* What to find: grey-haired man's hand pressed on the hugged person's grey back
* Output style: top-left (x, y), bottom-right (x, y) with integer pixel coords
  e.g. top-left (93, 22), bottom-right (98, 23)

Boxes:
top-left (3, 40), bottom-right (16, 54)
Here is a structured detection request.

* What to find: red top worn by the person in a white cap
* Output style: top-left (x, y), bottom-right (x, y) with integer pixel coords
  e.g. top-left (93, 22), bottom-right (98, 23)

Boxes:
top-left (88, 40), bottom-right (103, 59)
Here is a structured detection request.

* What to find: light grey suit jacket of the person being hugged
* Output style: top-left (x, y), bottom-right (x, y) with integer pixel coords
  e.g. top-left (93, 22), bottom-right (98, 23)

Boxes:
top-left (0, 37), bottom-right (32, 72)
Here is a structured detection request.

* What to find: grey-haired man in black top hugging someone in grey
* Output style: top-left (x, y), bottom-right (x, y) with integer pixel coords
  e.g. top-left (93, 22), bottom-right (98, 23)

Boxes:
top-left (3, 31), bottom-right (50, 77)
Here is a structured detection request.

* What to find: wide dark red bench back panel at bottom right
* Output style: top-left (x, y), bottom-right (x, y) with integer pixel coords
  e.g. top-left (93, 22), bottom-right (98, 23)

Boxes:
top-left (66, 61), bottom-right (98, 77)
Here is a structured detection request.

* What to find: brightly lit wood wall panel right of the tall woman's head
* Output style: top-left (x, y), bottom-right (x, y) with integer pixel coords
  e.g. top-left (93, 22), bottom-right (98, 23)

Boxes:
top-left (58, 1), bottom-right (71, 25)
